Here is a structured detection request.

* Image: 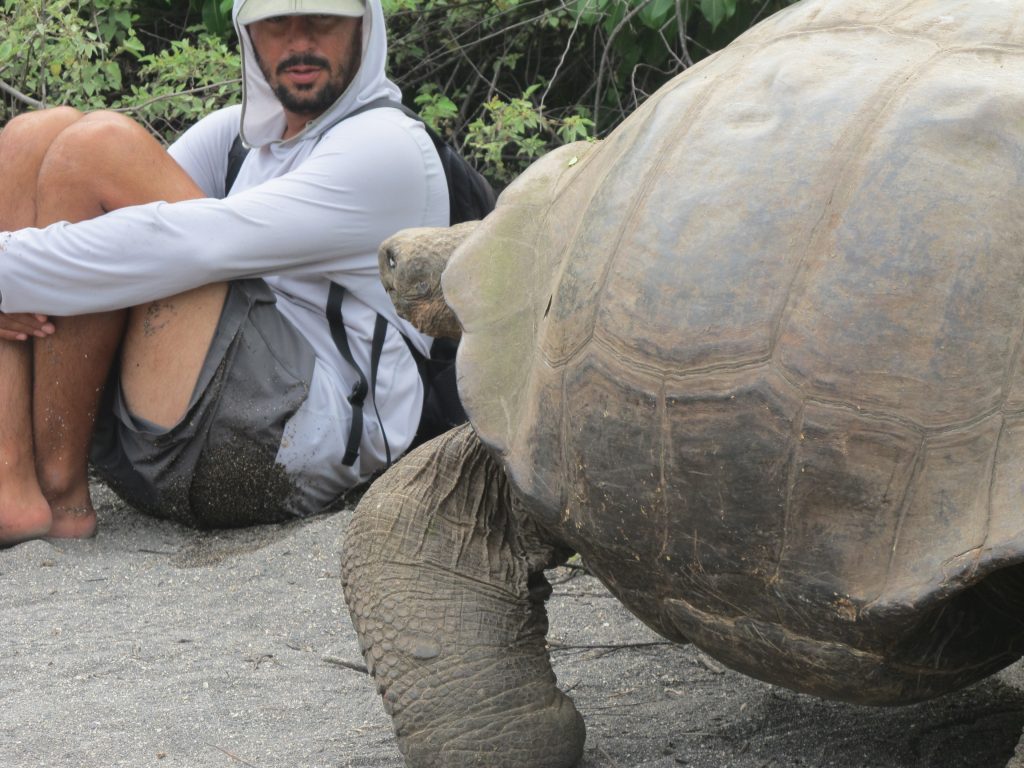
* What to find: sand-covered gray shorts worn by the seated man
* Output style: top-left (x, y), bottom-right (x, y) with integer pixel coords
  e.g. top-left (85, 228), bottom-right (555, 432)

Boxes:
top-left (91, 280), bottom-right (315, 528)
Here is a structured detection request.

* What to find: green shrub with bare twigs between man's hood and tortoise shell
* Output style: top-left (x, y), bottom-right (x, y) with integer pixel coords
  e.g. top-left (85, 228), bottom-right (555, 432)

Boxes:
top-left (384, 0), bottom-right (793, 183)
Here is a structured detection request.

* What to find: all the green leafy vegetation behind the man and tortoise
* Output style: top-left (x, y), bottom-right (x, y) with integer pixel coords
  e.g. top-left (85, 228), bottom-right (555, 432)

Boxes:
top-left (0, 0), bottom-right (793, 184)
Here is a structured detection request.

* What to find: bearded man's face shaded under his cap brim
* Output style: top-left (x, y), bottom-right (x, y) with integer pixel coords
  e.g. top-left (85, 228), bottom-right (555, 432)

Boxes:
top-left (246, 14), bottom-right (362, 120)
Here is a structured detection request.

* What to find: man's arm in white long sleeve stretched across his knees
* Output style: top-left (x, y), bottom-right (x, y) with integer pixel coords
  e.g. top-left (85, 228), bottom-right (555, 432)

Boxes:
top-left (0, 111), bottom-right (437, 314)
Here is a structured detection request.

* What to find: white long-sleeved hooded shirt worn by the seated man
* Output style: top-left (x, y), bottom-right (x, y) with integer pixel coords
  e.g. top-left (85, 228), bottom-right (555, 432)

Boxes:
top-left (0, 0), bottom-right (449, 514)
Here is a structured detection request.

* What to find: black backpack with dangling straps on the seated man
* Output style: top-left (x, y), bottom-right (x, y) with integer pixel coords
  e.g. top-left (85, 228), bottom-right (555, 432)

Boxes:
top-left (224, 98), bottom-right (495, 466)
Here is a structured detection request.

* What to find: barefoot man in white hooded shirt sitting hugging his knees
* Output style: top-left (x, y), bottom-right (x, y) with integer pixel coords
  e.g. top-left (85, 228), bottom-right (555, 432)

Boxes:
top-left (0, 0), bottom-right (449, 545)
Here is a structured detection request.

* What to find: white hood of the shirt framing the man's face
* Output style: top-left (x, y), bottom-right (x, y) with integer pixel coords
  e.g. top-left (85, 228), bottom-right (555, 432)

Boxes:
top-left (231, 0), bottom-right (401, 146)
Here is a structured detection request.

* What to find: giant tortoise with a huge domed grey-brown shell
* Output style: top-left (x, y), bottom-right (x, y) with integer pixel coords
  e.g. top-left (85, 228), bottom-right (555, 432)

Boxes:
top-left (343, 0), bottom-right (1024, 768)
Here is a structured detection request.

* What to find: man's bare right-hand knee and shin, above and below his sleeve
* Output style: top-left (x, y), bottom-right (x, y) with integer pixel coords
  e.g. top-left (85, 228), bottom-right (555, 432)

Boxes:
top-left (33, 113), bottom-right (214, 537)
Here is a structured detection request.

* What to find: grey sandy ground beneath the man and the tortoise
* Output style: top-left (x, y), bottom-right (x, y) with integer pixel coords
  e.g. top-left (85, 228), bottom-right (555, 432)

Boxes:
top-left (0, 485), bottom-right (1024, 768)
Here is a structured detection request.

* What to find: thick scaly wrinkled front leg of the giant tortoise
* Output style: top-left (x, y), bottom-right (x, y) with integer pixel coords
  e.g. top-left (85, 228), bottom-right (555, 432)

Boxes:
top-left (342, 426), bottom-right (584, 768)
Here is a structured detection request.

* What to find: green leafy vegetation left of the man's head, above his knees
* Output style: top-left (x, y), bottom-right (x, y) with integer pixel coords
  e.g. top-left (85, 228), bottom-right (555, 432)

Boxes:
top-left (0, 0), bottom-right (241, 141)
